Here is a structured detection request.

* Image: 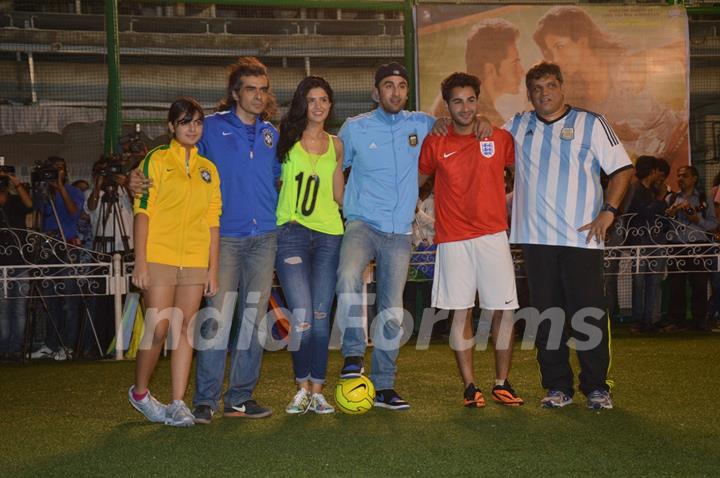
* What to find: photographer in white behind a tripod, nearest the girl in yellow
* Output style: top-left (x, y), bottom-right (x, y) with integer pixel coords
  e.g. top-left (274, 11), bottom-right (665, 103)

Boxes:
top-left (84, 155), bottom-right (133, 253)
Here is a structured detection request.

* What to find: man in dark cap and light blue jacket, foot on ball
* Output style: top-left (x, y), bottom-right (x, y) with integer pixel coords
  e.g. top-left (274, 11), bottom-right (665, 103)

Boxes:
top-left (337, 63), bottom-right (435, 410)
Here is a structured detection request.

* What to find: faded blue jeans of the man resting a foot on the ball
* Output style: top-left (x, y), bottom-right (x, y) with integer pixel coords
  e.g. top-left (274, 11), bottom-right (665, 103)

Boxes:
top-left (336, 221), bottom-right (412, 390)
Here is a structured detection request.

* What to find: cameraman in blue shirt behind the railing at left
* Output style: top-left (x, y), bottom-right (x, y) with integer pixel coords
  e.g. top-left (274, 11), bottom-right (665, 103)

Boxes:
top-left (31, 156), bottom-right (85, 360)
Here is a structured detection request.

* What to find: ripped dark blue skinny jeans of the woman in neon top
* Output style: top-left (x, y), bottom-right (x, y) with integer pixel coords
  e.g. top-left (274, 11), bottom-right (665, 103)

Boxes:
top-left (275, 223), bottom-right (342, 383)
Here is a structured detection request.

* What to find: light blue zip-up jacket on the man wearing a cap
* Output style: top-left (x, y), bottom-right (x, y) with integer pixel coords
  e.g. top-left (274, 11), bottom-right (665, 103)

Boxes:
top-left (338, 108), bottom-right (435, 234)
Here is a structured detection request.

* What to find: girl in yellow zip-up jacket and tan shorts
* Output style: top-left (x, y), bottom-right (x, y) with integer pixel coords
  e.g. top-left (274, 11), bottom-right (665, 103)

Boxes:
top-left (128, 98), bottom-right (221, 426)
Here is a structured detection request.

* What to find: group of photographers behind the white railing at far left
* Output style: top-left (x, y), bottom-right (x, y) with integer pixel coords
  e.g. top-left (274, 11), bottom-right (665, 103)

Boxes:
top-left (0, 156), bottom-right (133, 361)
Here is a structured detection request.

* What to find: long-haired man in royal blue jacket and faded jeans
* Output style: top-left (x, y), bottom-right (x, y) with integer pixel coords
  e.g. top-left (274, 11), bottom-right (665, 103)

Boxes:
top-left (193, 57), bottom-right (280, 423)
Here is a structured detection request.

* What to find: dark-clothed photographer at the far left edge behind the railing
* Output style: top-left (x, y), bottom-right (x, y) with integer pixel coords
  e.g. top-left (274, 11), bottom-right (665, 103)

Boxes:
top-left (0, 163), bottom-right (32, 361)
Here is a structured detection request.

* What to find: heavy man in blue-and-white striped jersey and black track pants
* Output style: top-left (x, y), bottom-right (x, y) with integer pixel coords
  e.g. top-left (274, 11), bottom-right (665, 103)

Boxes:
top-left (505, 62), bottom-right (632, 409)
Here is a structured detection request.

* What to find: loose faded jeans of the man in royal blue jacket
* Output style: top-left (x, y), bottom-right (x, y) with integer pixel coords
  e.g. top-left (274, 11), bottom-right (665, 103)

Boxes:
top-left (193, 231), bottom-right (277, 410)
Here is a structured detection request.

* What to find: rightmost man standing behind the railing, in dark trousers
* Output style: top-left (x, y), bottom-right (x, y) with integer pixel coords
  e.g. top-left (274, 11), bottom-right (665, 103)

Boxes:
top-left (663, 166), bottom-right (718, 332)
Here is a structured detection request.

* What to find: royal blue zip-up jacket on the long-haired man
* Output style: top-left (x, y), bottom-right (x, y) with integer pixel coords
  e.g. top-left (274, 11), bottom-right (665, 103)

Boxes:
top-left (198, 111), bottom-right (280, 237)
